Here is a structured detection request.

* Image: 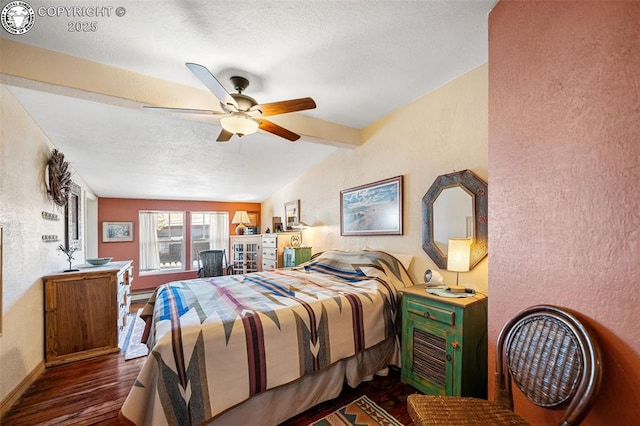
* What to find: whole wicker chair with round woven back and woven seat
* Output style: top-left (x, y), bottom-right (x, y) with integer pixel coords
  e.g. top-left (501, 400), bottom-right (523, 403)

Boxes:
top-left (407, 305), bottom-right (602, 425)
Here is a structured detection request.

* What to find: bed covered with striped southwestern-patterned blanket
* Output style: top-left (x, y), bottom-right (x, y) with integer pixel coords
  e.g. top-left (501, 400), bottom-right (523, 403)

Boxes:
top-left (120, 250), bottom-right (413, 425)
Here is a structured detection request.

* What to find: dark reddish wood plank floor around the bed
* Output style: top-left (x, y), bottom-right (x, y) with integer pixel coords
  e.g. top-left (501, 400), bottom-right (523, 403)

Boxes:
top-left (0, 342), bottom-right (416, 425)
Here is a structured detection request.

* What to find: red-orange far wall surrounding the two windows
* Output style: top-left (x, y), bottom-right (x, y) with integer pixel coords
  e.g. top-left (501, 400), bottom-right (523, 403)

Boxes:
top-left (98, 198), bottom-right (260, 291)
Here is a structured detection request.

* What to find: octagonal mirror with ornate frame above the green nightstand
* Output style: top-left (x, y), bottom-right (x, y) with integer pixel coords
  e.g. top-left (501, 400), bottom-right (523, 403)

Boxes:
top-left (422, 170), bottom-right (489, 269)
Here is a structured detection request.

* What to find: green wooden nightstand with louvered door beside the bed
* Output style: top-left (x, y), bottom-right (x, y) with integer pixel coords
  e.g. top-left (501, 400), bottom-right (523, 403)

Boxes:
top-left (401, 286), bottom-right (487, 399)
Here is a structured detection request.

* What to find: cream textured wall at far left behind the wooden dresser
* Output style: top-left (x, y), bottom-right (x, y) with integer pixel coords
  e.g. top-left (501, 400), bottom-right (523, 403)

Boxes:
top-left (0, 85), bottom-right (95, 401)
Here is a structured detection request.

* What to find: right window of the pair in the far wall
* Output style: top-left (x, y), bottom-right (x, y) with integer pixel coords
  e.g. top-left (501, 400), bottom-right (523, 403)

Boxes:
top-left (190, 212), bottom-right (229, 269)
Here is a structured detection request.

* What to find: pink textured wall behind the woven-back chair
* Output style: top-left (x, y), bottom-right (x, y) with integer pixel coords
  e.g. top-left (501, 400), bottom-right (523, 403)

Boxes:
top-left (489, 1), bottom-right (640, 425)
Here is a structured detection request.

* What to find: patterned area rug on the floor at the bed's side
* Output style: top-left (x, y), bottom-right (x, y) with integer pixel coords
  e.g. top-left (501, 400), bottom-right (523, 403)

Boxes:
top-left (310, 396), bottom-right (403, 426)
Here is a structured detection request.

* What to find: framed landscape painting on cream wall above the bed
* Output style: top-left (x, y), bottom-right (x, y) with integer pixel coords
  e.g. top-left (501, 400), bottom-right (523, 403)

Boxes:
top-left (340, 176), bottom-right (402, 236)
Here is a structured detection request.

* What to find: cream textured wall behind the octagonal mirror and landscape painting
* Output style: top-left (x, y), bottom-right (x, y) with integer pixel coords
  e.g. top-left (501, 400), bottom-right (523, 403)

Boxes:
top-left (262, 64), bottom-right (491, 291)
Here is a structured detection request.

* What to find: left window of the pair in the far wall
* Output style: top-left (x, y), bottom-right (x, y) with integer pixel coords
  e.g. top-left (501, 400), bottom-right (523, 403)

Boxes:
top-left (139, 211), bottom-right (185, 274)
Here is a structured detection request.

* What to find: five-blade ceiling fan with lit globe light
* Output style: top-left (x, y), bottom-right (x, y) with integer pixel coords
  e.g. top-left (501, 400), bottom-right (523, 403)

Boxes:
top-left (143, 62), bottom-right (316, 142)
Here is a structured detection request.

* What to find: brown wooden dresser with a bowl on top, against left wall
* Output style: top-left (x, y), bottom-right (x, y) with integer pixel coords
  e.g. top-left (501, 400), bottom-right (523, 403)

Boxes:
top-left (43, 260), bottom-right (133, 367)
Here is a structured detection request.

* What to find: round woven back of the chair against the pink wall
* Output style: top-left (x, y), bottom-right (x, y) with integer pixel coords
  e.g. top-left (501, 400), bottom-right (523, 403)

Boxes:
top-left (496, 305), bottom-right (602, 424)
